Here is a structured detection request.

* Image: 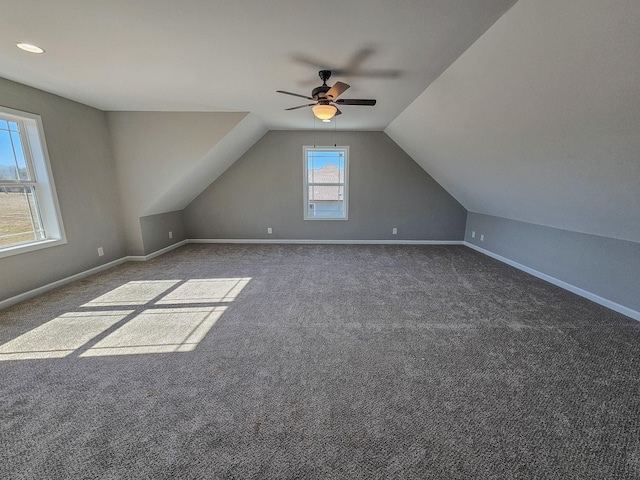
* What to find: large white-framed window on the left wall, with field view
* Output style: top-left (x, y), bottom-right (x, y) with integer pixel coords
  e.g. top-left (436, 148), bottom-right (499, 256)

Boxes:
top-left (0, 107), bottom-right (66, 257)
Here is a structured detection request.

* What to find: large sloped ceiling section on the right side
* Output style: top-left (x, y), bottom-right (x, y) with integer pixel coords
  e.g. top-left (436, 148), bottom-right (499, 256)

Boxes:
top-left (385, 0), bottom-right (640, 242)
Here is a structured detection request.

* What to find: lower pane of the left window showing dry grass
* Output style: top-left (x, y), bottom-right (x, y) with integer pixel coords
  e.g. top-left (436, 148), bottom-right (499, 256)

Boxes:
top-left (0, 186), bottom-right (46, 247)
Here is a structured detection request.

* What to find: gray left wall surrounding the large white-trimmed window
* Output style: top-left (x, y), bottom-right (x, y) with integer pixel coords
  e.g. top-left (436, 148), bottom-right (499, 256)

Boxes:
top-left (0, 78), bottom-right (124, 300)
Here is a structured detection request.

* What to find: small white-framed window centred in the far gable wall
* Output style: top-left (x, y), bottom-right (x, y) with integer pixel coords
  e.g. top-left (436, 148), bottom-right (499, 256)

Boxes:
top-left (304, 147), bottom-right (349, 220)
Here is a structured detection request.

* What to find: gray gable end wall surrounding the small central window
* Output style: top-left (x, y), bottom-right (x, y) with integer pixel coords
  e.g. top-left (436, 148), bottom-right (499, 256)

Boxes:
top-left (184, 131), bottom-right (466, 240)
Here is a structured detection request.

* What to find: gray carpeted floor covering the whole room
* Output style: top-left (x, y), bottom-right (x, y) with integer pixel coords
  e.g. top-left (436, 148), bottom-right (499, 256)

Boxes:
top-left (0, 245), bottom-right (640, 480)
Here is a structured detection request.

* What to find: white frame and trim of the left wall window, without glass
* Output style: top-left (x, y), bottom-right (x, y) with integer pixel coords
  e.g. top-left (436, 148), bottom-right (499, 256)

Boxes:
top-left (0, 106), bottom-right (67, 258)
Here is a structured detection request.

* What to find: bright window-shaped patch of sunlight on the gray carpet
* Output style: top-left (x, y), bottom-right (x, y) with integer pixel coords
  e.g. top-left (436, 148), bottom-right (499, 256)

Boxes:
top-left (0, 278), bottom-right (251, 361)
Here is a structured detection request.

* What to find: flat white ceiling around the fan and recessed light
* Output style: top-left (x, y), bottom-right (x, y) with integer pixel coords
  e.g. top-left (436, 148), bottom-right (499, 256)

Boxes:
top-left (0, 0), bottom-right (516, 130)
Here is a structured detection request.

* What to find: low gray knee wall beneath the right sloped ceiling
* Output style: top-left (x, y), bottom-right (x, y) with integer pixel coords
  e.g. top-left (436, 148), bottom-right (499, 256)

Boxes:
top-left (465, 212), bottom-right (640, 312)
